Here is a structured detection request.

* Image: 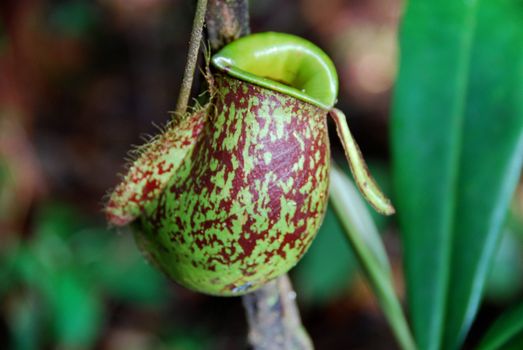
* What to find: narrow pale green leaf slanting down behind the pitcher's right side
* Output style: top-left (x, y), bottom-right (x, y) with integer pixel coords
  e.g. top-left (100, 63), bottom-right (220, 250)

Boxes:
top-left (330, 166), bottom-right (416, 350)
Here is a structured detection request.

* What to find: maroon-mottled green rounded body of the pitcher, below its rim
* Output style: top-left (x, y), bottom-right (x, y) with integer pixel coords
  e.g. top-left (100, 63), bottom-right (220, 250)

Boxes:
top-left (137, 75), bottom-right (330, 295)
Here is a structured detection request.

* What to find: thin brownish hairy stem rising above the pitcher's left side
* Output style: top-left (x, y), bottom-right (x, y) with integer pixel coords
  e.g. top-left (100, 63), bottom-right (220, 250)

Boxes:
top-left (175, 0), bottom-right (207, 116)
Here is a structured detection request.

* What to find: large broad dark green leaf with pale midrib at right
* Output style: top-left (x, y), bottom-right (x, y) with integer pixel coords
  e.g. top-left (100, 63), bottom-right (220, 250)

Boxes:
top-left (392, 0), bottom-right (523, 350)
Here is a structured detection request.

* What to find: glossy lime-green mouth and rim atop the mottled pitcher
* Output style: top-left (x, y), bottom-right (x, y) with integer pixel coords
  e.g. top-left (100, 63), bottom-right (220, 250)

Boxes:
top-left (211, 32), bottom-right (338, 110)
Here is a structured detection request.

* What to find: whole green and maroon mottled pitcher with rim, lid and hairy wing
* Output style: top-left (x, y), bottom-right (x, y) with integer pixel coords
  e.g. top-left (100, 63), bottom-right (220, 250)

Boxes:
top-left (106, 33), bottom-right (394, 296)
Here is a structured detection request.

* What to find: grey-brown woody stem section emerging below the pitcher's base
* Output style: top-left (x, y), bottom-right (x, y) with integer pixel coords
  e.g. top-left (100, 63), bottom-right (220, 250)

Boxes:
top-left (243, 275), bottom-right (313, 350)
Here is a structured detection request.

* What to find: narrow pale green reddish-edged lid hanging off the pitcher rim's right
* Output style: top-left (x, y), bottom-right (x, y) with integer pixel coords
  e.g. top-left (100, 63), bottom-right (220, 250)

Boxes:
top-left (329, 108), bottom-right (396, 215)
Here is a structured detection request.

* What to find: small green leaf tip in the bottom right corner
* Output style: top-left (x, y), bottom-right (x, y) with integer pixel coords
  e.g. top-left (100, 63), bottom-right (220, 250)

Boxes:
top-left (478, 304), bottom-right (523, 350)
